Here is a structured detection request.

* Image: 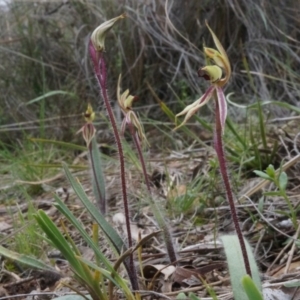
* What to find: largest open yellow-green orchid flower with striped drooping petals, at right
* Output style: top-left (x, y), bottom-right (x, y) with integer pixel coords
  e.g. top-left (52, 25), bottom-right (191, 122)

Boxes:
top-left (175, 22), bottom-right (231, 133)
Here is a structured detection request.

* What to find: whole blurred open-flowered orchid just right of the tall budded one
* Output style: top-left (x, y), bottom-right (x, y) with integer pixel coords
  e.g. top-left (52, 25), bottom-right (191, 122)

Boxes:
top-left (117, 75), bottom-right (177, 265)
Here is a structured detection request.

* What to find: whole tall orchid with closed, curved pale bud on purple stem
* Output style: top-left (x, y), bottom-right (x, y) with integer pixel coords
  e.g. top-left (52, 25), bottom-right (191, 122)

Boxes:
top-left (89, 14), bottom-right (138, 290)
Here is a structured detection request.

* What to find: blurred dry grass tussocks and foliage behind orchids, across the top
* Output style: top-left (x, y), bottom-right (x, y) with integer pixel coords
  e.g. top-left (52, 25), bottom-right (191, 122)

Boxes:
top-left (0, 0), bottom-right (300, 143)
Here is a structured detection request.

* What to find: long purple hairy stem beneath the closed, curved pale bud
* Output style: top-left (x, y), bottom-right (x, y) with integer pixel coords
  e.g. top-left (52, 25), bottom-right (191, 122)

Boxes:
top-left (90, 42), bottom-right (139, 290)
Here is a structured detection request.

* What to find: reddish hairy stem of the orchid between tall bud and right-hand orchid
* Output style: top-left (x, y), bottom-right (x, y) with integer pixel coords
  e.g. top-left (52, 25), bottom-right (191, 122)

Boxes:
top-left (128, 122), bottom-right (177, 264)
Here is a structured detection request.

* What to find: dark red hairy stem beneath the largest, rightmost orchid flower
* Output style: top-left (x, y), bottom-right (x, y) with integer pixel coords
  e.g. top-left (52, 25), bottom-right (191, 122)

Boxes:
top-left (214, 95), bottom-right (251, 277)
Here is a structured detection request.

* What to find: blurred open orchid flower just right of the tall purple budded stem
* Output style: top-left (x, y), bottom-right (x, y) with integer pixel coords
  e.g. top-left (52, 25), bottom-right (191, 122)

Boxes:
top-left (117, 75), bottom-right (149, 146)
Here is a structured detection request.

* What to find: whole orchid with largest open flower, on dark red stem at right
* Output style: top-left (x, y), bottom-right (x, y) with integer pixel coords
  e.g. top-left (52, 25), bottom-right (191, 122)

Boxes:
top-left (175, 23), bottom-right (251, 276)
